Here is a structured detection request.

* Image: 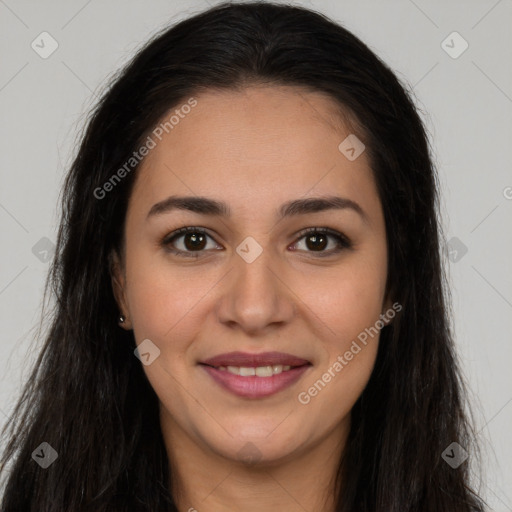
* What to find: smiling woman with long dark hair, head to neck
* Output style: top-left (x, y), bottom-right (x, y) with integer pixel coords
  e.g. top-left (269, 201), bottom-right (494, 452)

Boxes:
top-left (2, 3), bottom-right (483, 512)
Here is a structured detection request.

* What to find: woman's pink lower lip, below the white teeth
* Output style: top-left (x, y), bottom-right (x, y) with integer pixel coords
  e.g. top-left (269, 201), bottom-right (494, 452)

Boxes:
top-left (201, 364), bottom-right (311, 398)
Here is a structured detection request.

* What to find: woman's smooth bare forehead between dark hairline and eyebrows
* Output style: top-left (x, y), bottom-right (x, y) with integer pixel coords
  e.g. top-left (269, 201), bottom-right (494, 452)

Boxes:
top-left (127, 86), bottom-right (375, 218)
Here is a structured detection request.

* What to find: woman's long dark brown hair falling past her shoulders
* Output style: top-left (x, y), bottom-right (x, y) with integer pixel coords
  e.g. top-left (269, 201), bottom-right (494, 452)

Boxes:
top-left (0, 2), bottom-right (483, 512)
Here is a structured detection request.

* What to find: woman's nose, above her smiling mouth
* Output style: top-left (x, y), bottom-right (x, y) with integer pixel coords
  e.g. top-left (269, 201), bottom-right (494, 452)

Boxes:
top-left (217, 244), bottom-right (296, 335)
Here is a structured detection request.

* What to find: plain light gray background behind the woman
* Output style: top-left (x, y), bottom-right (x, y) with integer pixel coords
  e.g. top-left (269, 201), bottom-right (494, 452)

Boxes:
top-left (0, 0), bottom-right (512, 511)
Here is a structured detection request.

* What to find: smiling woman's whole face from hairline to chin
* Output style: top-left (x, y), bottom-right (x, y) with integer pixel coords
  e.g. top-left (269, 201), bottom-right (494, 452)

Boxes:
top-left (113, 86), bottom-right (389, 462)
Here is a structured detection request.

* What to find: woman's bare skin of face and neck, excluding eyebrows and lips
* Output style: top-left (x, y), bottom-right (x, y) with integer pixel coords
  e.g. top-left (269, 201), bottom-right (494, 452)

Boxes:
top-left (113, 86), bottom-right (391, 512)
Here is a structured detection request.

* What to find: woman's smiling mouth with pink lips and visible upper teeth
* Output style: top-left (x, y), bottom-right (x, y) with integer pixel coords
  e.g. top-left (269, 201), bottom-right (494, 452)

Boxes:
top-left (199, 352), bottom-right (312, 399)
